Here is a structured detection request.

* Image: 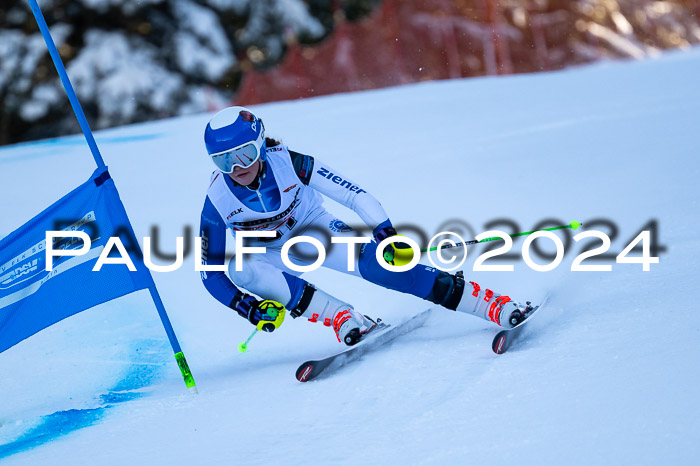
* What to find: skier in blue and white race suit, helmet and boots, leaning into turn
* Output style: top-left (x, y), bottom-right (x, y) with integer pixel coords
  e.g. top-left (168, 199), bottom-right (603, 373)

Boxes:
top-left (200, 107), bottom-right (523, 345)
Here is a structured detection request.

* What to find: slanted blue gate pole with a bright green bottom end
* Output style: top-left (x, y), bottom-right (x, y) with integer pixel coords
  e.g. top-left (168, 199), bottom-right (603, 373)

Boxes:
top-left (27, 0), bottom-right (197, 393)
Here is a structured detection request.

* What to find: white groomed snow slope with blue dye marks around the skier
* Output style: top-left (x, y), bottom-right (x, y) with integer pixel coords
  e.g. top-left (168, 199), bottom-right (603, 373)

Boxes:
top-left (0, 50), bottom-right (700, 465)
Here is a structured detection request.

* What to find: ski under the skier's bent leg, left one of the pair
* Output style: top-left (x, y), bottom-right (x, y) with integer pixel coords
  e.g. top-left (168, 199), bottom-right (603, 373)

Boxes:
top-left (296, 309), bottom-right (430, 382)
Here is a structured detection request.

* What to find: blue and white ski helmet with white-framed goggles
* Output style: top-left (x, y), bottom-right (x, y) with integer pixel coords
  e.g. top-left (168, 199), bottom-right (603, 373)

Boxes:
top-left (204, 107), bottom-right (266, 173)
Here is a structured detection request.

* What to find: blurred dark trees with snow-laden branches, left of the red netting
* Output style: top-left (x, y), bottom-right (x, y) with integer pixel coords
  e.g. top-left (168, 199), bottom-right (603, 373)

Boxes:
top-left (0, 0), bottom-right (379, 144)
